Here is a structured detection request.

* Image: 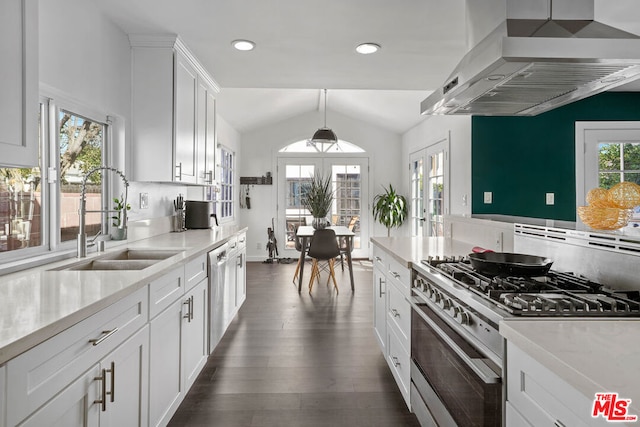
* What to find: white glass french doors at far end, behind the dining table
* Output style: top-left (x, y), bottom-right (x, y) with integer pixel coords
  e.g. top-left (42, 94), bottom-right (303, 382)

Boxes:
top-left (276, 156), bottom-right (369, 258)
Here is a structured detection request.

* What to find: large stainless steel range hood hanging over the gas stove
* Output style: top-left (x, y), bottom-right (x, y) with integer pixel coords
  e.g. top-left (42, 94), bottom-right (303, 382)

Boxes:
top-left (420, 0), bottom-right (640, 116)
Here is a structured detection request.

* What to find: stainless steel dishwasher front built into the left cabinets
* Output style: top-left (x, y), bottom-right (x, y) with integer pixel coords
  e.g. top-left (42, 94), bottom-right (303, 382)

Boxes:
top-left (209, 243), bottom-right (229, 354)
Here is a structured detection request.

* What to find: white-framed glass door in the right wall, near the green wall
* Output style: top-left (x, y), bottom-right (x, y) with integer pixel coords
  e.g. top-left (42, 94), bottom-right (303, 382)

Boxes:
top-left (409, 136), bottom-right (449, 237)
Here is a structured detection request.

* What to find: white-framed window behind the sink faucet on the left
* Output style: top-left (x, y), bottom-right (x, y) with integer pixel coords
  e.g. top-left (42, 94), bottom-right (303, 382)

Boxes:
top-left (0, 99), bottom-right (107, 260)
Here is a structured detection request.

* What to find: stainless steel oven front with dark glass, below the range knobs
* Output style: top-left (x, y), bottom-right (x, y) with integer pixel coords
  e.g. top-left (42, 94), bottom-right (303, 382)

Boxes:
top-left (411, 301), bottom-right (502, 427)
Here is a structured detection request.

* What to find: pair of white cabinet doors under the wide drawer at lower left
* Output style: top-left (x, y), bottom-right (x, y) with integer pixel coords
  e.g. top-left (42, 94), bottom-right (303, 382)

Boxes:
top-left (20, 326), bottom-right (149, 427)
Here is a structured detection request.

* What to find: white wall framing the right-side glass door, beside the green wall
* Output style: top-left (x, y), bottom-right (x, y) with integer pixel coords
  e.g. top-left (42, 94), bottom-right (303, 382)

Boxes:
top-left (400, 116), bottom-right (471, 229)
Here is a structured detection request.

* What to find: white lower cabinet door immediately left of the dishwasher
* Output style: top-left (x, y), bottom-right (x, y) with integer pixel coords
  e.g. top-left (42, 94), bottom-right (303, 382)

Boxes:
top-left (181, 278), bottom-right (209, 390)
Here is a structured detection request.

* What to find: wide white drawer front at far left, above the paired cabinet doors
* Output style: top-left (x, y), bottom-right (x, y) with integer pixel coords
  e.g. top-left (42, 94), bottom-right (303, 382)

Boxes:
top-left (6, 287), bottom-right (148, 426)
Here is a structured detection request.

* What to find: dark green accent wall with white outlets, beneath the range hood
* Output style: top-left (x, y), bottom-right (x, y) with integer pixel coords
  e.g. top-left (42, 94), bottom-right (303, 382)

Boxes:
top-left (471, 92), bottom-right (640, 221)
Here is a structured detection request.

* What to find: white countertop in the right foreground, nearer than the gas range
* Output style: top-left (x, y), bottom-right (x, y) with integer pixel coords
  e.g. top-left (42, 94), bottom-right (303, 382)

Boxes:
top-left (500, 319), bottom-right (640, 414)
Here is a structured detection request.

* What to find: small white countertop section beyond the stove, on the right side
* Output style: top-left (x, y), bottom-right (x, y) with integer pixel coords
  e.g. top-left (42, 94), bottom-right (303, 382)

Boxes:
top-left (371, 237), bottom-right (473, 268)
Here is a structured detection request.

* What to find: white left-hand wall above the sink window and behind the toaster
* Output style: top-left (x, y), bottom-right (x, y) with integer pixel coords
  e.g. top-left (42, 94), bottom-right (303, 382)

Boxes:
top-left (39, 0), bottom-right (239, 232)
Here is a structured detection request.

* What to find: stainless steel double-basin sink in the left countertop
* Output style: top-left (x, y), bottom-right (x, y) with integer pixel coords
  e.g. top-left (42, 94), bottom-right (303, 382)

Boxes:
top-left (52, 249), bottom-right (182, 271)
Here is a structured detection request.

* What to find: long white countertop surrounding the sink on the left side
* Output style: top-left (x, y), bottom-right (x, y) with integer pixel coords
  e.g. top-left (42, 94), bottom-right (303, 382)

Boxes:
top-left (0, 227), bottom-right (245, 365)
